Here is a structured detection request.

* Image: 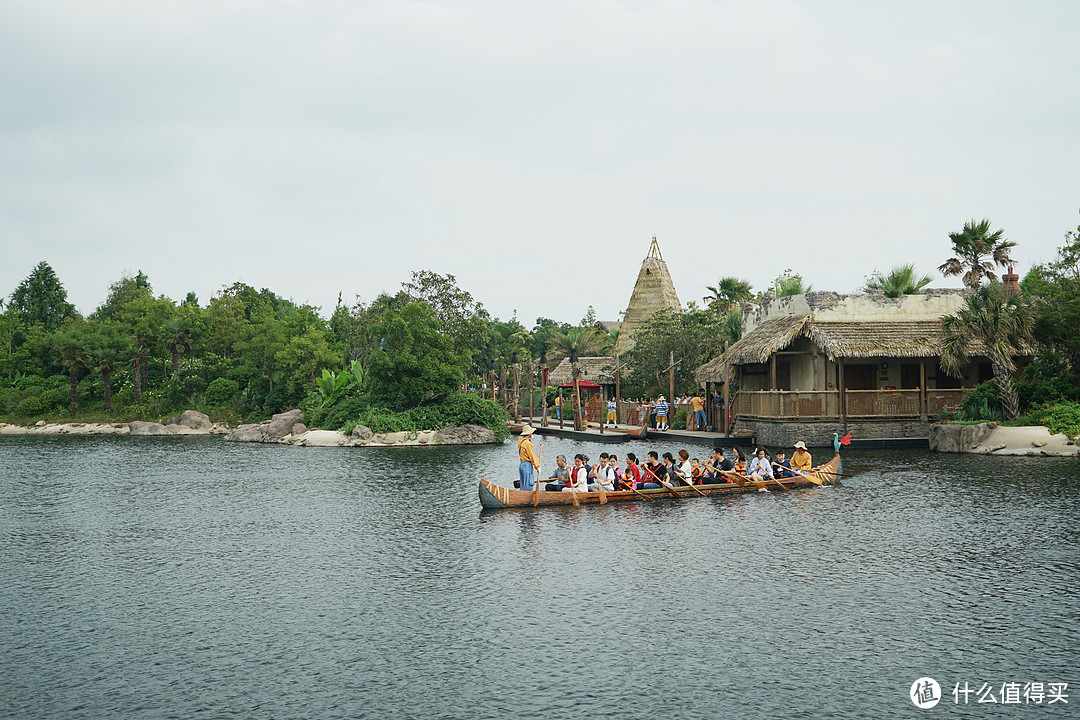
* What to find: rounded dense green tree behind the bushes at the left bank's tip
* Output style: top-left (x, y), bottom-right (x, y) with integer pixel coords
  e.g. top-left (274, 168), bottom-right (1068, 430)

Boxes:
top-left (366, 302), bottom-right (467, 410)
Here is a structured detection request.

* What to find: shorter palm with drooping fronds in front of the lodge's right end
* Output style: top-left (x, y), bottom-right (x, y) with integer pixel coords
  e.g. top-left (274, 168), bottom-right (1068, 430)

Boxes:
top-left (941, 283), bottom-right (1035, 420)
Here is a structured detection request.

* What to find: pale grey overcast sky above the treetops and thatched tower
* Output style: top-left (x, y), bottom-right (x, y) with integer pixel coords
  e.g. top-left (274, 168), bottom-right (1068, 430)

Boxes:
top-left (0, 0), bottom-right (1080, 326)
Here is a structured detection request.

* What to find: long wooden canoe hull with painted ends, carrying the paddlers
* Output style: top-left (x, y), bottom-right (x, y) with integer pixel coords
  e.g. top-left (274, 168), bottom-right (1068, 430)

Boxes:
top-left (478, 452), bottom-right (840, 508)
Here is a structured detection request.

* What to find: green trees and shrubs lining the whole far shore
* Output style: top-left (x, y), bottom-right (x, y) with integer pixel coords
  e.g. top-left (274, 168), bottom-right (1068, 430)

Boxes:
top-left (0, 215), bottom-right (1080, 451)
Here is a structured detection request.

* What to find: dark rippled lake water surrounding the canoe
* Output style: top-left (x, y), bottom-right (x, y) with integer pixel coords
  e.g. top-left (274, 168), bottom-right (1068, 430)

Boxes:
top-left (0, 437), bottom-right (1080, 720)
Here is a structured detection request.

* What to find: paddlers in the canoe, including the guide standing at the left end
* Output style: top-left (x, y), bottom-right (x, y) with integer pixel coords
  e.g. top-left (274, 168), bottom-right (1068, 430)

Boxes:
top-left (517, 425), bottom-right (813, 492)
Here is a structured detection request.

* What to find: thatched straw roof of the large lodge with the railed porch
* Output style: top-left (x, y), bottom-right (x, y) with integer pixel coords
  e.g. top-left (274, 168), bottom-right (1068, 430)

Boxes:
top-left (693, 315), bottom-right (980, 384)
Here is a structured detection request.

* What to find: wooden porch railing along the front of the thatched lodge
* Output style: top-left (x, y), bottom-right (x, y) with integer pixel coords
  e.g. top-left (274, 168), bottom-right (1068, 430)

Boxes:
top-left (731, 390), bottom-right (963, 418)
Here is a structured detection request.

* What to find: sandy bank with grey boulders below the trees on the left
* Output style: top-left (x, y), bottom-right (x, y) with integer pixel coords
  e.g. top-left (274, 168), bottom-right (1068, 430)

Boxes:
top-left (0, 410), bottom-right (496, 447)
